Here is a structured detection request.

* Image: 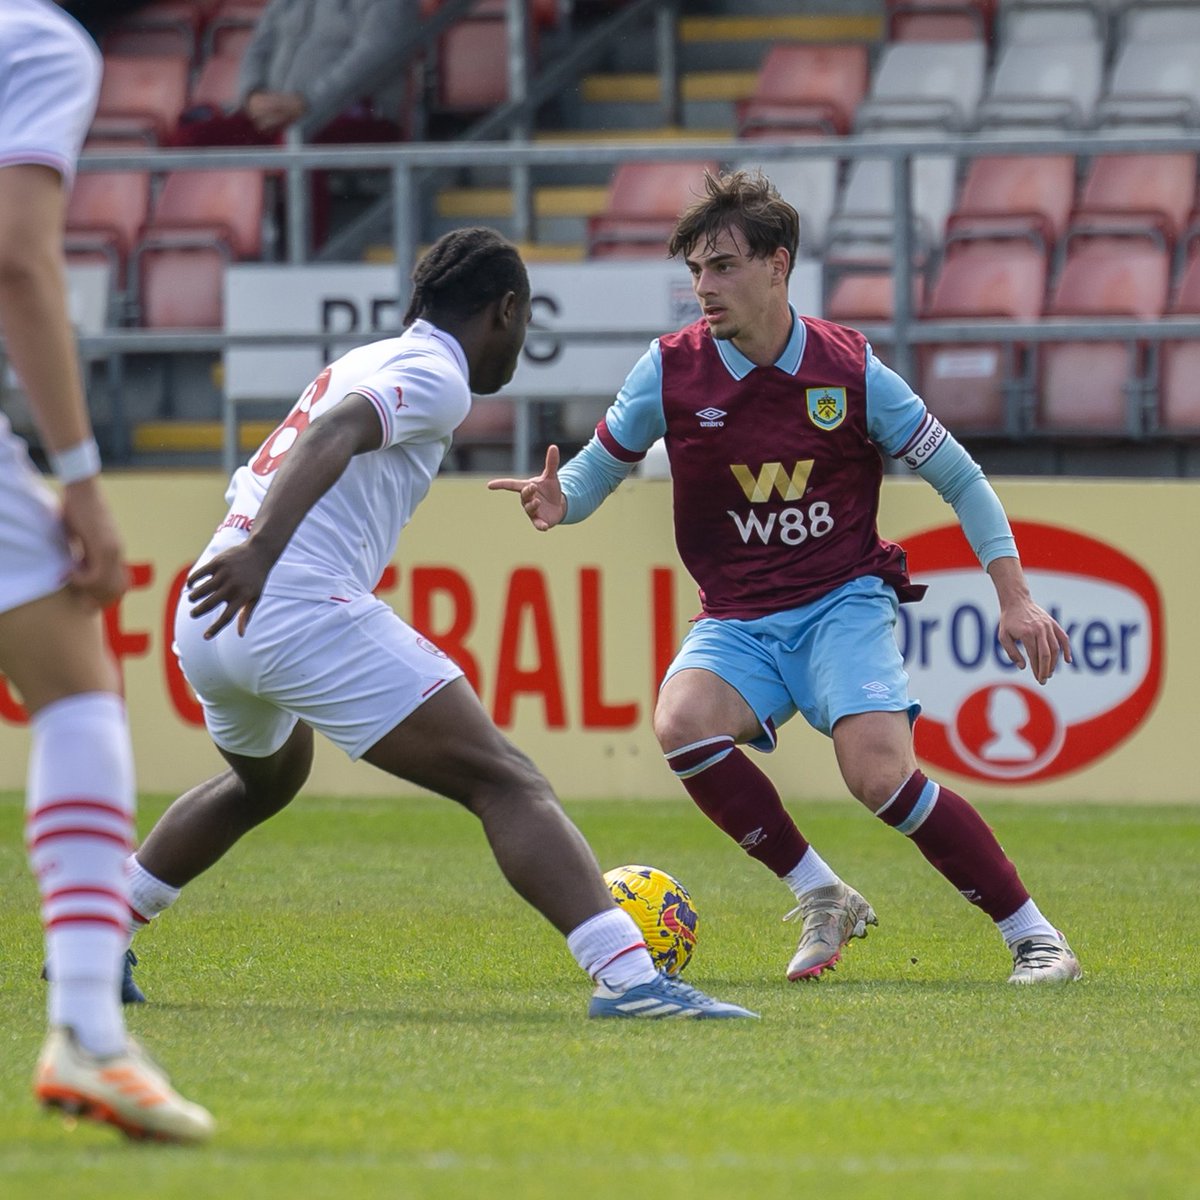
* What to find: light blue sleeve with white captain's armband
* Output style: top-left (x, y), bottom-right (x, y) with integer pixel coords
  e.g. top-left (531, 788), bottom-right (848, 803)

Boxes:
top-left (866, 347), bottom-right (1018, 570)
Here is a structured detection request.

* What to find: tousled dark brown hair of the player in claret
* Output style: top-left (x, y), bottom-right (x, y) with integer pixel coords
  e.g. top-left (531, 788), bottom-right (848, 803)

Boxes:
top-left (667, 170), bottom-right (800, 276)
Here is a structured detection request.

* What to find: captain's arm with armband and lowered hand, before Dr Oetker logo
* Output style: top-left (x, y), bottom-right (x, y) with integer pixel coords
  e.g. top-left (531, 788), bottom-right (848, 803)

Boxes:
top-left (866, 352), bottom-right (1072, 684)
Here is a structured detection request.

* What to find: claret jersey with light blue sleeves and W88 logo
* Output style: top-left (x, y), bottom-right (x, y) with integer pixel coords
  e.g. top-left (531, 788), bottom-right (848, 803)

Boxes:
top-left (560, 304), bottom-right (1016, 619)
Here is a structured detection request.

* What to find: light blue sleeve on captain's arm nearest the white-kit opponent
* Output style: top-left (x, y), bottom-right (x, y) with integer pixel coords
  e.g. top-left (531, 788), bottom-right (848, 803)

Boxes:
top-left (558, 341), bottom-right (667, 524)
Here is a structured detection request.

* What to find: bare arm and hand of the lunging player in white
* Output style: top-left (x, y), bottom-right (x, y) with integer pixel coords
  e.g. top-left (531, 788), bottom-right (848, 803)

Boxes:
top-left (187, 392), bottom-right (383, 638)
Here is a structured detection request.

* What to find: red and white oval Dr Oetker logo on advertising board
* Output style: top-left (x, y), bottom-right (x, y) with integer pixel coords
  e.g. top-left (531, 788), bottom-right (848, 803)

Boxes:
top-left (896, 521), bottom-right (1164, 784)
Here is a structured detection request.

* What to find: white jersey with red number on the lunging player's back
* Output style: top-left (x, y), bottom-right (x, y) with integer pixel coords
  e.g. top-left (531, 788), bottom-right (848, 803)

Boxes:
top-left (199, 320), bottom-right (470, 600)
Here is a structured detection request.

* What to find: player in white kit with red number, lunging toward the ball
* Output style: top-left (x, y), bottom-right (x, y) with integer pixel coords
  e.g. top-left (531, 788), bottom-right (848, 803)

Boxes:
top-left (121, 229), bottom-right (755, 1018)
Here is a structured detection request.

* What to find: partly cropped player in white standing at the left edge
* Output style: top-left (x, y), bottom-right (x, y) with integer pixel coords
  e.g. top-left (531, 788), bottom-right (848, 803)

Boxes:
top-left (0, 0), bottom-right (214, 1141)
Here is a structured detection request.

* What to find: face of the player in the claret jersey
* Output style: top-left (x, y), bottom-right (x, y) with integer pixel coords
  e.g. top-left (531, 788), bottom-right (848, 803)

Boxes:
top-left (684, 228), bottom-right (787, 341)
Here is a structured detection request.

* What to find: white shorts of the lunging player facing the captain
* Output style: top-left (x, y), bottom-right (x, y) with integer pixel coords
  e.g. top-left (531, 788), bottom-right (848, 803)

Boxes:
top-left (175, 592), bottom-right (462, 758)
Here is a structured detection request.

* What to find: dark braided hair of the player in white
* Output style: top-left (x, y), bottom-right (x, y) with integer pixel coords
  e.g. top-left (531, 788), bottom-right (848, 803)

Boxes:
top-left (404, 227), bottom-right (529, 328)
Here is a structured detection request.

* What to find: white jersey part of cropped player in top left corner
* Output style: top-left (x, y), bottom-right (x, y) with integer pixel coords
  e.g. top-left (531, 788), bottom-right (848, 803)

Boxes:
top-left (0, 0), bottom-right (101, 182)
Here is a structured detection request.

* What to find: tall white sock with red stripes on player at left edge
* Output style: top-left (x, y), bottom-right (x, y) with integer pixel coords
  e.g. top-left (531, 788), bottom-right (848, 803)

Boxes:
top-left (25, 692), bottom-right (134, 1055)
